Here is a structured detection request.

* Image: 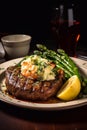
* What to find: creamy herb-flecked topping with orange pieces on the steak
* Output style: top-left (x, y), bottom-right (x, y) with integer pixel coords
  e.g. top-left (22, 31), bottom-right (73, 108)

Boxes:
top-left (21, 55), bottom-right (55, 81)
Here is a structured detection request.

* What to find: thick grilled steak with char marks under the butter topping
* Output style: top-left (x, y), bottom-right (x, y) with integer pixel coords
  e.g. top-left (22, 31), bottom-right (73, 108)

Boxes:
top-left (5, 66), bottom-right (64, 101)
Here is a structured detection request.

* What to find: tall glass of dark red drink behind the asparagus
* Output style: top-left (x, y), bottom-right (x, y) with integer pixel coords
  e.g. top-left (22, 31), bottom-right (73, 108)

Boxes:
top-left (51, 3), bottom-right (80, 56)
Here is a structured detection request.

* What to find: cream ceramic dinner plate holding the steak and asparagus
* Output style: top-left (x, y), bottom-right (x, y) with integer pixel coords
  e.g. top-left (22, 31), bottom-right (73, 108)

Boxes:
top-left (0, 58), bottom-right (87, 111)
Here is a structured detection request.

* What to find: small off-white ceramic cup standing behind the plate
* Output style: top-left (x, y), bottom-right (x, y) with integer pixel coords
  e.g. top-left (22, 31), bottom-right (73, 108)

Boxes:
top-left (1, 34), bottom-right (32, 59)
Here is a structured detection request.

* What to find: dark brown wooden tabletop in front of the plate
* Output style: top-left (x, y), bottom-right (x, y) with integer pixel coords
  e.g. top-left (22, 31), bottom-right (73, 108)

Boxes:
top-left (0, 101), bottom-right (87, 130)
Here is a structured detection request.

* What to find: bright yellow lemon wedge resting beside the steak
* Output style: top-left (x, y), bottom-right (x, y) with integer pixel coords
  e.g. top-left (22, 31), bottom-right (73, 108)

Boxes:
top-left (57, 75), bottom-right (81, 101)
